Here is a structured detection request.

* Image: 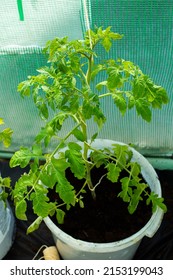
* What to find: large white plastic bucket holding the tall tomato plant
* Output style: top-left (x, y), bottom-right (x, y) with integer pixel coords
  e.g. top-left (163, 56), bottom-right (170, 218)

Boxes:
top-left (44, 139), bottom-right (163, 260)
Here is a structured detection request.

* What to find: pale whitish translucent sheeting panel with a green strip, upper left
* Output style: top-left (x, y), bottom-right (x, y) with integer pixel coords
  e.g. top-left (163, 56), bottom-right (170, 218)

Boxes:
top-left (0, 0), bottom-right (82, 47)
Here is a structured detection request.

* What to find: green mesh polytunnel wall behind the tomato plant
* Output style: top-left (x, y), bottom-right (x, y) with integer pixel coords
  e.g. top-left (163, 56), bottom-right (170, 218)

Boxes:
top-left (0, 0), bottom-right (173, 161)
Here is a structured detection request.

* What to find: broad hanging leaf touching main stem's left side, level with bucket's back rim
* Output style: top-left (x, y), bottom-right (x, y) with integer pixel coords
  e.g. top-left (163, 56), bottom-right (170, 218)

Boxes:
top-left (65, 142), bottom-right (85, 179)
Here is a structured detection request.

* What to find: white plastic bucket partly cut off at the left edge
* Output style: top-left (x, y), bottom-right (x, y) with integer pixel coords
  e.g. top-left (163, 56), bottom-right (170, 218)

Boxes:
top-left (0, 201), bottom-right (14, 259)
